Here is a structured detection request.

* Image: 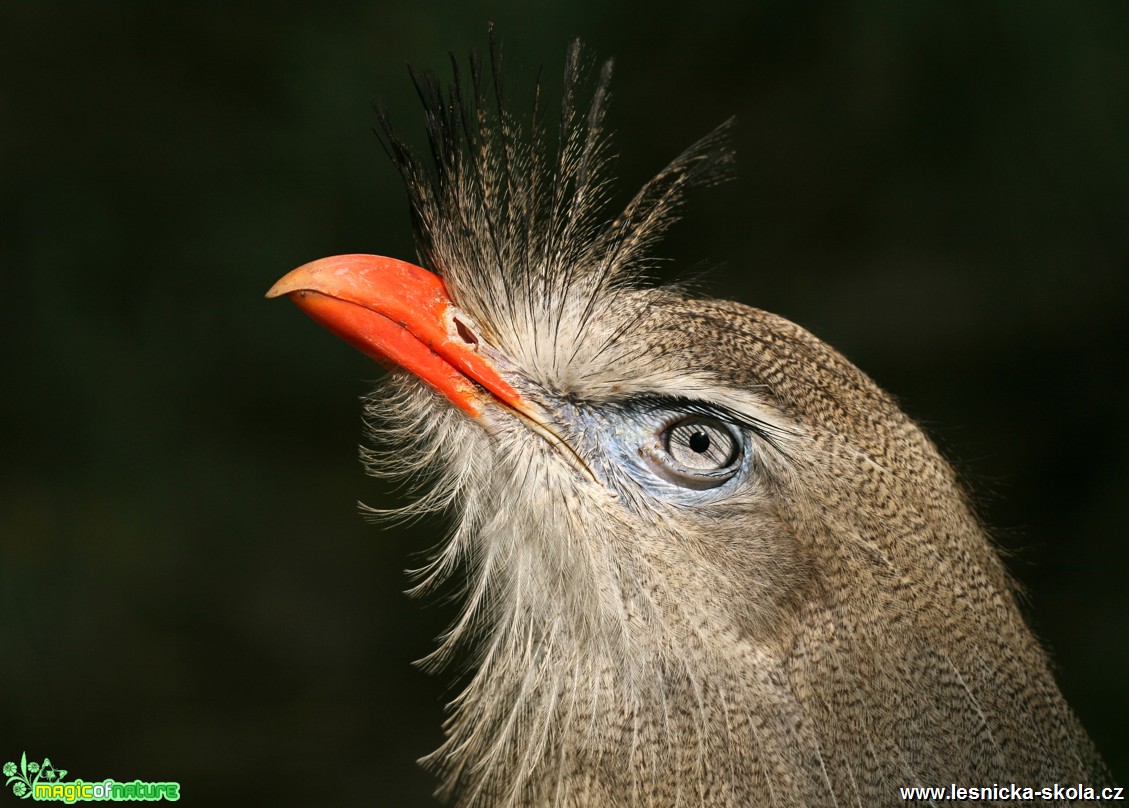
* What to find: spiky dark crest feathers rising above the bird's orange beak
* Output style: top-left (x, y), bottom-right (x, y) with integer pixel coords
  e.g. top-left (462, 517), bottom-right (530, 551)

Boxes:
top-left (379, 29), bottom-right (735, 330)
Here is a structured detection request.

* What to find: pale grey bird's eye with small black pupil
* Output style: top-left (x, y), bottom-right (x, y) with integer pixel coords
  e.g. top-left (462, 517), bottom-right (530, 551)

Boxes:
top-left (649, 415), bottom-right (741, 489)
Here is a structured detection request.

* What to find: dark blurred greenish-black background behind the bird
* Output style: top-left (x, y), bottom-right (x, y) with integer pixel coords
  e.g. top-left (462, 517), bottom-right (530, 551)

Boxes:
top-left (0, 0), bottom-right (1129, 806)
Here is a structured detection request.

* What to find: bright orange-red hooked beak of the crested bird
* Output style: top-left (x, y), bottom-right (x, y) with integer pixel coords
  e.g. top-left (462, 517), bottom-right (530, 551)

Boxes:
top-left (266, 255), bottom-right (530, 416)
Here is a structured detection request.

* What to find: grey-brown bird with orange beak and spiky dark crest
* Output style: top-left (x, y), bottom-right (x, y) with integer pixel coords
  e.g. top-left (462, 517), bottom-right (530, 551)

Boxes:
top-left (268, 30), bottom-right (1117, 808)
